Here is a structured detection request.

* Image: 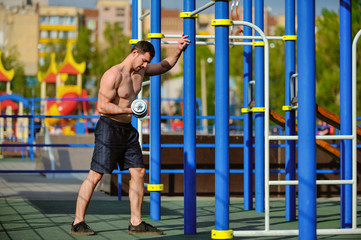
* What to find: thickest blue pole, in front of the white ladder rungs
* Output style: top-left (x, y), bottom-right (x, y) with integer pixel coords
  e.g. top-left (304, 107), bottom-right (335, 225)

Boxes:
top-left (297, 0), bottom-right (316, 240)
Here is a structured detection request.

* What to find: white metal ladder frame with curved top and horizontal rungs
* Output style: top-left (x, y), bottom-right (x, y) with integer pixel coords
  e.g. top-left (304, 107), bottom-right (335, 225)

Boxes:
top-left (233, 24), bottom-right (361, 240)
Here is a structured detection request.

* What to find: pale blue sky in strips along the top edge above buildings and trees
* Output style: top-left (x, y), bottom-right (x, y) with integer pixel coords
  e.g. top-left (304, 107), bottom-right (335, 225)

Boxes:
top-left (49, 0), bottom-right (339, 15)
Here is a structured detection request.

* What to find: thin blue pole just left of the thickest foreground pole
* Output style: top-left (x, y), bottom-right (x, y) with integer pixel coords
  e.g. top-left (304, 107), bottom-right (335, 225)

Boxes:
top-left (285, 0), bottom-right (296, 221)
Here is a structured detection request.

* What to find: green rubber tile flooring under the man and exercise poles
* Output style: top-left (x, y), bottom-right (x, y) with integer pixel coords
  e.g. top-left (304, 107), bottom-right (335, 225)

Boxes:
top-left (0, 198), bottom-right (361, 240)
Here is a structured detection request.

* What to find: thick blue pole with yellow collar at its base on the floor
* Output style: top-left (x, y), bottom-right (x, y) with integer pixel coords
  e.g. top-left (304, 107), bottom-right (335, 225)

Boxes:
top-left (215, 1), bottom-right (229, 231)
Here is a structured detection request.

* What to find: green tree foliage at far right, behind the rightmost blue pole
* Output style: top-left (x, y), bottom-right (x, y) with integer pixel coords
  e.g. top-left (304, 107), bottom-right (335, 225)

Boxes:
top-left (316, 0), bottom-right (361, 116)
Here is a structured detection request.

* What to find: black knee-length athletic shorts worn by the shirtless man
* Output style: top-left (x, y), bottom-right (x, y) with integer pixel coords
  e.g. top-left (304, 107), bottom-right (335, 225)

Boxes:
top-left (90, 116), bottom-right (144, 173)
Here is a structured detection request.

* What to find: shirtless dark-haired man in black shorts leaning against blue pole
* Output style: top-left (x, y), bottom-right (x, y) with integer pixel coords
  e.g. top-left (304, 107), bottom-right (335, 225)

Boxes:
top-left (70, 35), bottom-right (190, 235)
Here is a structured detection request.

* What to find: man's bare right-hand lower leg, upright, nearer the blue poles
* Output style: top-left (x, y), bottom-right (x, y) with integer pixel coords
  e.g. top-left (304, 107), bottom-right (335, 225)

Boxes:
top-left (129, 168), bottom-right (145, 226)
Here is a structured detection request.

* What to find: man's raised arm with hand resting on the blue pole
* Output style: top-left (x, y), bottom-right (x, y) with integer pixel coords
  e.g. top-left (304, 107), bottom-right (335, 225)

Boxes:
top-left (145, 34), bottom-right (190, 76)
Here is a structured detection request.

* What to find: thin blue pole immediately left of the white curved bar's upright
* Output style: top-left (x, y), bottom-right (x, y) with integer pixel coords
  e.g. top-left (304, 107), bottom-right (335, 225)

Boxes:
top-left (254, 0), bottom-right (264, 212)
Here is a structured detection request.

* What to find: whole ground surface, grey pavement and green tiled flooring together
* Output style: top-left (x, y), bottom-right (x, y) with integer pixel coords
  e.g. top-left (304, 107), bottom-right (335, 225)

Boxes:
top-left (0, 157), bottom-right (361, 240)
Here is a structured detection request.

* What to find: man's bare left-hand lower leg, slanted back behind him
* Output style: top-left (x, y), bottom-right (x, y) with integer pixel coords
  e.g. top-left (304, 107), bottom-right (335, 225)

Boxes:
top-left (73, 170), bottom-right (103, 225)
